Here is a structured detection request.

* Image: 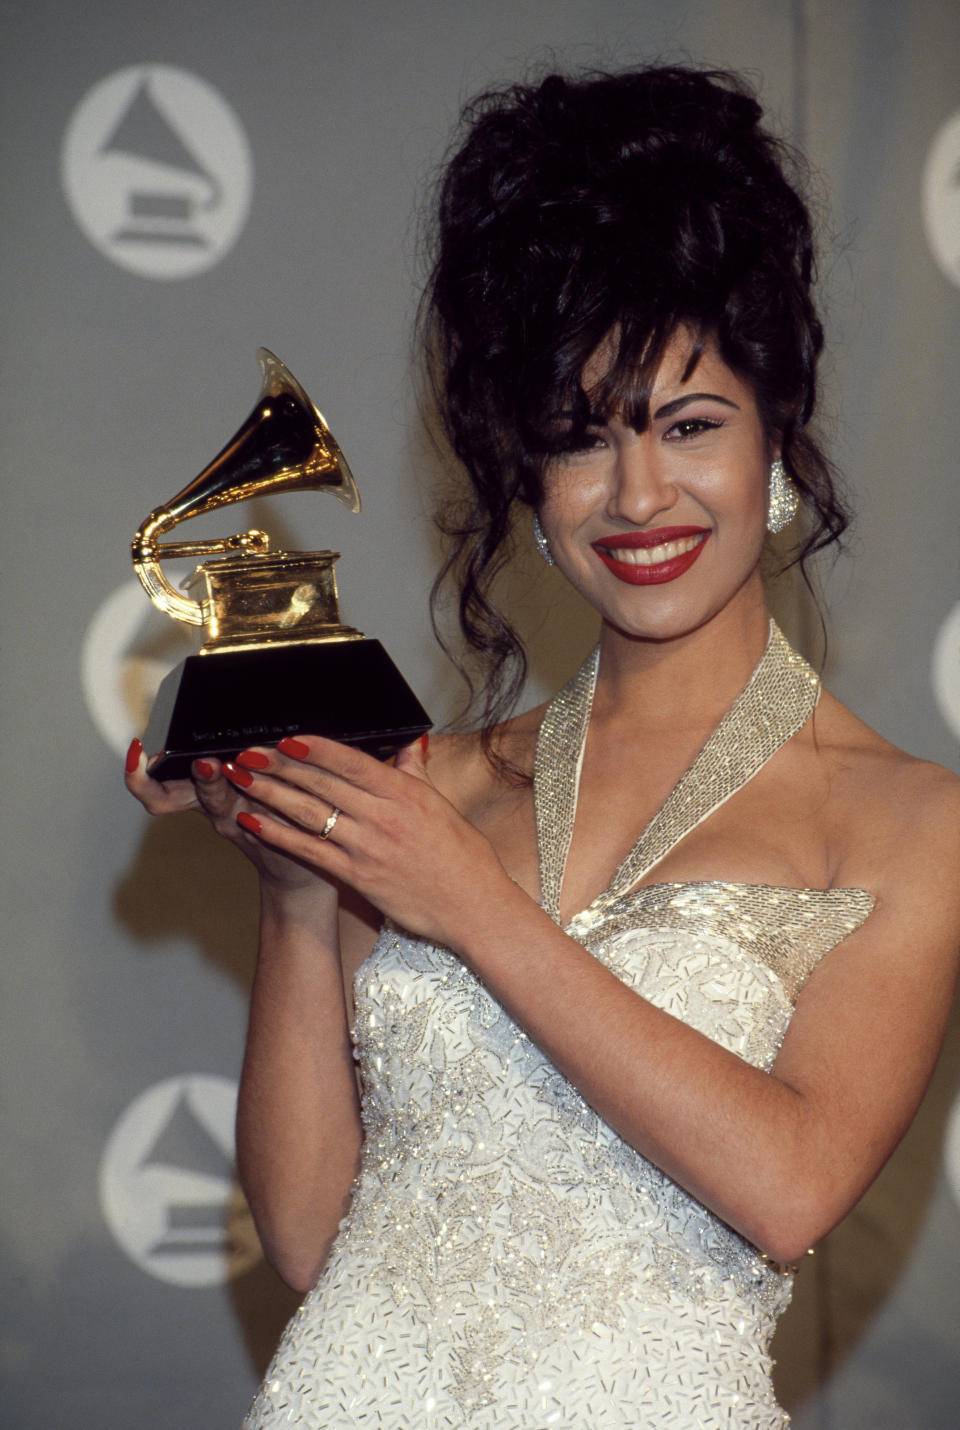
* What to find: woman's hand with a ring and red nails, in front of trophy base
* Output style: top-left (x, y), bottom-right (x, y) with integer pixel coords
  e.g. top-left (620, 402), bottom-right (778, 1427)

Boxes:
top-left (223, 735), bottom-right (509, 950)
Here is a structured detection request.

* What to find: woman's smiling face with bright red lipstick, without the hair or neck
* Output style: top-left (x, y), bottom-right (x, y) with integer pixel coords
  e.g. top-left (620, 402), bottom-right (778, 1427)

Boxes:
top-left (539, 332), bottom-right (777, 639)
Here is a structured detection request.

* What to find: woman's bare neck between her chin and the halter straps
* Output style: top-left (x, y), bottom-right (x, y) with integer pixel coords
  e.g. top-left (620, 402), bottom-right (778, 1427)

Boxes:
top-left (594, 582), bottom-right (770, 731)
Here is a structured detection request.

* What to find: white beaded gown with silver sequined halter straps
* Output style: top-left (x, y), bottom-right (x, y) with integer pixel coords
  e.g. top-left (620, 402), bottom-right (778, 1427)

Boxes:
top-left (245, 626), bottom-right (873, 1430)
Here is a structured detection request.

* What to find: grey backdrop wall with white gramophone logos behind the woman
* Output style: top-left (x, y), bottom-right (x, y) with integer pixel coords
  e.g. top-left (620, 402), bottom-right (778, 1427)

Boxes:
top-left (0, 0), bottom-right (960, 1430)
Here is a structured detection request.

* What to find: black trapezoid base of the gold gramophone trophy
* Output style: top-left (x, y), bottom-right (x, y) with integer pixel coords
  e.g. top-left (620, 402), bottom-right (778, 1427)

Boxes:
top-left (143, 639), bottom-right (431, 779)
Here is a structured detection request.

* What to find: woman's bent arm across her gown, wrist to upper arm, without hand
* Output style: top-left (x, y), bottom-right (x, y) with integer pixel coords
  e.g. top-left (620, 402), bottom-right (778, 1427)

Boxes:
top-left (462, 835), bottom-right (960, 1261)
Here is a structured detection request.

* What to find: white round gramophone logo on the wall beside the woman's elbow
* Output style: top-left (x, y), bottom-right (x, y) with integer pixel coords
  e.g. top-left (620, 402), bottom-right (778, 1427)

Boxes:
top-left (100, 1077), bottom-right (262, 1286)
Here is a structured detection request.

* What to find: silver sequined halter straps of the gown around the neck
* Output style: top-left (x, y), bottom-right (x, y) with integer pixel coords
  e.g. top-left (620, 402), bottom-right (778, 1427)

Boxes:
top-left (534, 621), bottom-right (820, 918)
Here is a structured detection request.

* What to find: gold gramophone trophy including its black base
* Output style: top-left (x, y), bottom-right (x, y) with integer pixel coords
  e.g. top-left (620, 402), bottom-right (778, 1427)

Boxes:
top-left (133, 347), bottom-right (431, 779)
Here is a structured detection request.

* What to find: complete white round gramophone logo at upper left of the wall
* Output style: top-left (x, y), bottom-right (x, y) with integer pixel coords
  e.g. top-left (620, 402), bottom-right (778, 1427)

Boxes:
top-left (62, 64), bottom-right (253, 279)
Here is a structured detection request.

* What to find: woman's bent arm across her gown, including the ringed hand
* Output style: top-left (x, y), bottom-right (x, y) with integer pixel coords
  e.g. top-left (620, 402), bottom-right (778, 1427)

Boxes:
top-left (221, 741), bottom-right (960, 1261)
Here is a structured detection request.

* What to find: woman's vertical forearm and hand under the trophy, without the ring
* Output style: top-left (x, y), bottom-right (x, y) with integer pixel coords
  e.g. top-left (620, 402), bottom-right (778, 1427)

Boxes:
top-left (126, 742), bottom-right (376, 1290)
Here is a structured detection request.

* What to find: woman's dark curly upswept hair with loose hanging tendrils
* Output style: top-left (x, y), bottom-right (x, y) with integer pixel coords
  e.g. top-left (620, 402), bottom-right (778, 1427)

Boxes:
top-left (421, 67), bottom-right (847, 752)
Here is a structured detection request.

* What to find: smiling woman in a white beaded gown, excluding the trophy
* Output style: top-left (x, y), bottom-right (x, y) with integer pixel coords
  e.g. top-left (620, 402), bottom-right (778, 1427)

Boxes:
top-left (127, 69), bottom-right (960, 1430)
